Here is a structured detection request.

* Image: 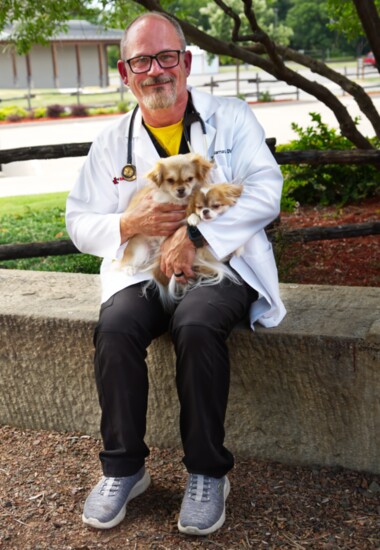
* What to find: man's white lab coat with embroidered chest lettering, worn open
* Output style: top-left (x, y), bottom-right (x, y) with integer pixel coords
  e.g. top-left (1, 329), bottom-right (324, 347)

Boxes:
top-left (66, 88), bottom-right (286, 328)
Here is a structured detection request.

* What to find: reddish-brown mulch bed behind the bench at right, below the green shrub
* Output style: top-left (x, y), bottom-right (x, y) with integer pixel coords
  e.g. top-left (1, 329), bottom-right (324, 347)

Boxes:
top-left (277, 196), bottom-right (380, 286)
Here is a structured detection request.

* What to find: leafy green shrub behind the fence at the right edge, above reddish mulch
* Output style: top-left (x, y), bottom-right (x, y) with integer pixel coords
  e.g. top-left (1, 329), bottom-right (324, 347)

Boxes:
top-left (276, 113), bottom-right (380, 210)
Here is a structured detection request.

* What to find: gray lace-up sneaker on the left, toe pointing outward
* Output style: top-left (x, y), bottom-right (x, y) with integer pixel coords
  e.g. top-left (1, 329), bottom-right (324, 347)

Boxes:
top-left (82, 467), bottom-right (150, 529)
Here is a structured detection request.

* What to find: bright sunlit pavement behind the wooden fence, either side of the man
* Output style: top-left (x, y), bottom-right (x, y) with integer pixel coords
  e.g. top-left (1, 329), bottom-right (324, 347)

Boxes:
top-left (0, 94), bottom-right (380, 201)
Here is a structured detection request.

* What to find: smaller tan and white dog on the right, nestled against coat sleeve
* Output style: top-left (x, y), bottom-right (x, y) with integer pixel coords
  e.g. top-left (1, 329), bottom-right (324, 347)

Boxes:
top-left (168, 183), bottom-right (243, 302)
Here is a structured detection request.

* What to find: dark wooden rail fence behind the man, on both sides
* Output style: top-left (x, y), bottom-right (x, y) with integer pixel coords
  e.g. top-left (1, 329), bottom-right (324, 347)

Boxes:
top-left (0, 142), bottom-right (380, 261)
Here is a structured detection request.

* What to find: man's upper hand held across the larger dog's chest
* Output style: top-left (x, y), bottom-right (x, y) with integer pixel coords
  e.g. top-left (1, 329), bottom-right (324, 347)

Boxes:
top-left (120, 193), bottom-right (186, 243)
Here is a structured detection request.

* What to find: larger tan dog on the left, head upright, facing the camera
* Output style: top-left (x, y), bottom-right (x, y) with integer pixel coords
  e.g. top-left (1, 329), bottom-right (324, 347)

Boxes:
top-left (116, 153), bottom-right (212, 276)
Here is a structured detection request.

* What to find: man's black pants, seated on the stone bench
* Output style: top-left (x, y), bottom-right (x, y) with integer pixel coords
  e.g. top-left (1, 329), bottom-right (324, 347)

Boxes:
top-left (94, 280), bottom-right (257, 477)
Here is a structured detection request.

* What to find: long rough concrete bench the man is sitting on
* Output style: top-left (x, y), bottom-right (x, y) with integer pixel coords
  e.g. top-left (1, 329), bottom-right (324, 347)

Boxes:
top-left (0, 270), bottom-right (380, 473)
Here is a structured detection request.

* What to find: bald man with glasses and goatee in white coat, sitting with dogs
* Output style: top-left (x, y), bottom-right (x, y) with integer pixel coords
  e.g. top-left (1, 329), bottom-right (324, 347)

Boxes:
top-left (67, 8), bottom-right (285, 535)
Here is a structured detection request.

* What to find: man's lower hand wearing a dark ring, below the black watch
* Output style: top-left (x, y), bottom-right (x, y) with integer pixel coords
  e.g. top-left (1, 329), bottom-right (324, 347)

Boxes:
top-left (161, 226), bottom-right (196, 283)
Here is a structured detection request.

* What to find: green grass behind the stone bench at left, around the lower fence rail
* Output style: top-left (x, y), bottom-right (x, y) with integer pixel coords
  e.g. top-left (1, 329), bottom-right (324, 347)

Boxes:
top-left (0, 193), bottom-right (100, 273)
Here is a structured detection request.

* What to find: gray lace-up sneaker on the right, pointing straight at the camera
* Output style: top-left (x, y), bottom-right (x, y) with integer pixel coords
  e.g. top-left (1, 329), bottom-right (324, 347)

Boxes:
top-left (178, 474), bottom-right (230, 535)
